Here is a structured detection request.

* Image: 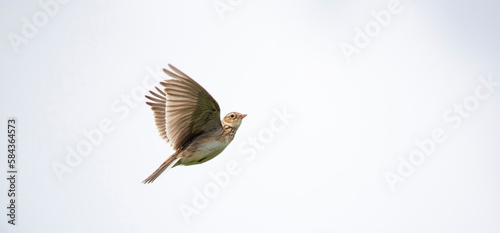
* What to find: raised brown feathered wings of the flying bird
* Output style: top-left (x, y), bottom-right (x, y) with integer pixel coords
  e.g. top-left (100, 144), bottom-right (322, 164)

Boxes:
top-left (147, 64), bottom-right (222, 150)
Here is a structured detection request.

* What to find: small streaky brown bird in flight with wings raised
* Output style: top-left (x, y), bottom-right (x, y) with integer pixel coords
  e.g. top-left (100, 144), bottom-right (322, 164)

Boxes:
top-left (142, 64), bottom-right (247, 184)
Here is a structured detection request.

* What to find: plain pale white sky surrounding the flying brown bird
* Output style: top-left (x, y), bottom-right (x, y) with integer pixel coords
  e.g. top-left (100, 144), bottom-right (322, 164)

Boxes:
top-left (0, 0), bottom-right (500, 233)
